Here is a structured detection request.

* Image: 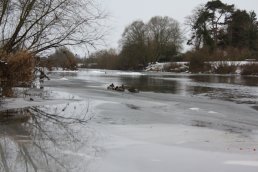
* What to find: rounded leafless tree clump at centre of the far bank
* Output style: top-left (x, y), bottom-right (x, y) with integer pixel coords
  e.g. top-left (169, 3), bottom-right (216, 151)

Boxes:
top-left (120, 16), bottom-right (183, 69)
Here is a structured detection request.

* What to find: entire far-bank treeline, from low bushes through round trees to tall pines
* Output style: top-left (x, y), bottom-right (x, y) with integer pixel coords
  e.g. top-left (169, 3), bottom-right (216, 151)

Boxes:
top-left (83, 0), bottom-right (258, 70)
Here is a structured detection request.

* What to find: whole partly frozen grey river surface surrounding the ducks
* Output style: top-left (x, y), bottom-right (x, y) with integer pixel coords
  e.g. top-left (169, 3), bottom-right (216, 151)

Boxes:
top-left (0, 70), bottom-right (258, 172)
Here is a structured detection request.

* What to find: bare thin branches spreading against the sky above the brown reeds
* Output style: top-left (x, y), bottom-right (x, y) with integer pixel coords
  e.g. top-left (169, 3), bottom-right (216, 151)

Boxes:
top-left (0, 0), bottom-right (105, 53)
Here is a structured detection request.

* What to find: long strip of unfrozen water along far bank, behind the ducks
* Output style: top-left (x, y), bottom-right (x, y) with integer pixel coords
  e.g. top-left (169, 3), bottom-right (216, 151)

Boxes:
top-left (52, 70), bottom-right (258, 108)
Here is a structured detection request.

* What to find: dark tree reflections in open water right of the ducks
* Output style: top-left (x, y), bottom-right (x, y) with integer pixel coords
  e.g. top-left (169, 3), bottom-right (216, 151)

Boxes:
top-left (119, 74), bottom-right (258, 104)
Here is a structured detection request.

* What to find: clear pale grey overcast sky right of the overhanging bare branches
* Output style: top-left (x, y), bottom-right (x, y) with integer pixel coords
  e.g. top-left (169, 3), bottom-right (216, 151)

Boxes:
top-left (101, 0), bottom-right (258, 51)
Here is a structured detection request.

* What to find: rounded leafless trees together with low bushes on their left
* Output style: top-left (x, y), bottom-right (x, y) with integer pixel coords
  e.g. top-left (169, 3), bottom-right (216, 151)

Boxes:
top-left (85, 16), bottom-right (183, 70)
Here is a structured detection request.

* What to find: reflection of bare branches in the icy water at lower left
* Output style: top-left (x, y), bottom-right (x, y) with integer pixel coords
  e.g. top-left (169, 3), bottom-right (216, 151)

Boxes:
top-left (0, 102), bottom-right (95, 172)
